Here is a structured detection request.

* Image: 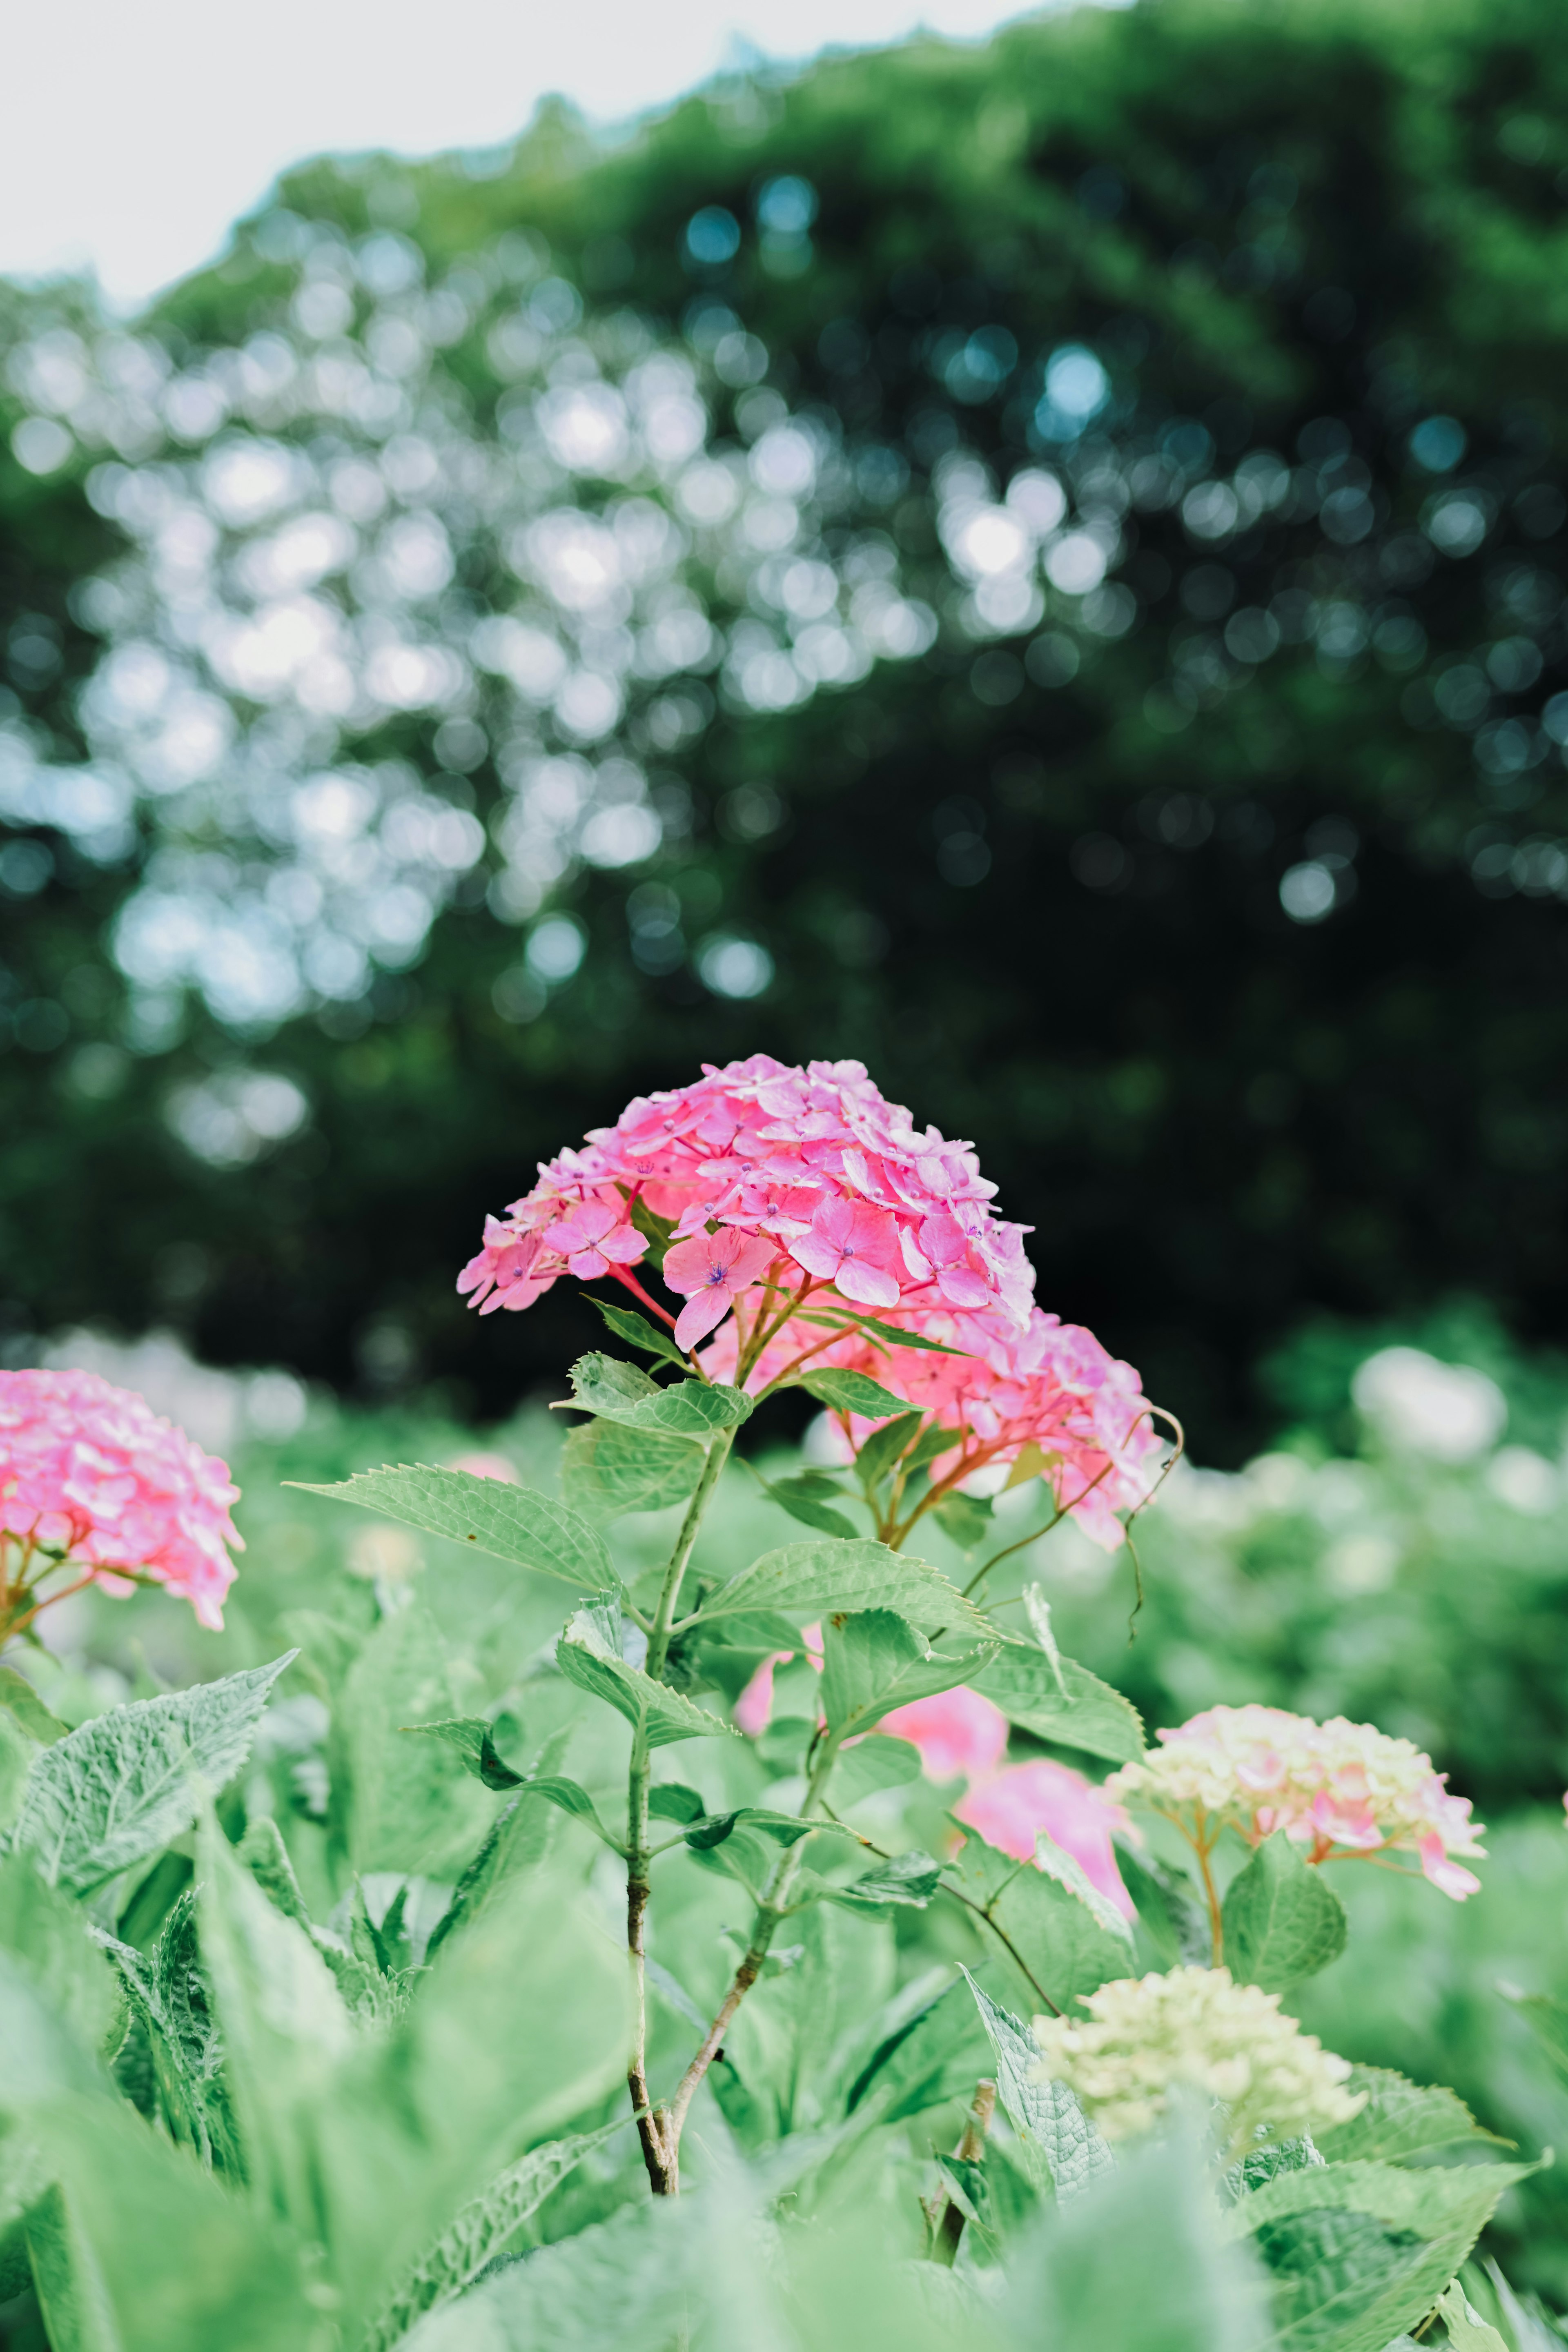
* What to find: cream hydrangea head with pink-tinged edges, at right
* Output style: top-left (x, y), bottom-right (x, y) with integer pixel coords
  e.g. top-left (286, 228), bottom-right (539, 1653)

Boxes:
top-left (1107, 1705), bottom-right (1486, 1903)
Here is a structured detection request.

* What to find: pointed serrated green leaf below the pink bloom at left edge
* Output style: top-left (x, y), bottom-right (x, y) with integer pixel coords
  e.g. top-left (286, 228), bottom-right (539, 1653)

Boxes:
top-left (12, 1651), bottom-right (296, 1893)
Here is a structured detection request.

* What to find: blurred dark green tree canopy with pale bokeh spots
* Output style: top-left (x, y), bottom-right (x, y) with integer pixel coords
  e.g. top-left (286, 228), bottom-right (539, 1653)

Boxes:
top-left (0, 0), bottom-right (1568, 1458)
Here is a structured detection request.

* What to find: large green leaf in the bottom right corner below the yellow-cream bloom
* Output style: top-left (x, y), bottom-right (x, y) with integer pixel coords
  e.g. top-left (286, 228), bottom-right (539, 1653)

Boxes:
top-left (1225, 2161), bottom-right (1530, 2352)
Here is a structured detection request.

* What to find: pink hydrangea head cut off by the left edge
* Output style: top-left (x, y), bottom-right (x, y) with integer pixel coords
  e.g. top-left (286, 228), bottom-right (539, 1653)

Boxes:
top-left (0, 1371), bottom-right (242, 1630)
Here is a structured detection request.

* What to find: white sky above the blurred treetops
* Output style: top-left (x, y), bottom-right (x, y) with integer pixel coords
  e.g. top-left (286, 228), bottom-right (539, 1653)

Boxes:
top-left (0, 0), bottom-right (1034, 306)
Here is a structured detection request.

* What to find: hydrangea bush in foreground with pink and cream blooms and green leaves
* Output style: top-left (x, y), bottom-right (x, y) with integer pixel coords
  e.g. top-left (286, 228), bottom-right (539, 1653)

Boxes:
top-left (0, 1056), bottom-right (1535, 2352)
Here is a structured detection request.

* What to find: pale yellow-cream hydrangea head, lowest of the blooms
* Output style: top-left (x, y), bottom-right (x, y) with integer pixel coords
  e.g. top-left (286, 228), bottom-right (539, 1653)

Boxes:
top-left (1034, 1969), bottom-right (1366, 2161)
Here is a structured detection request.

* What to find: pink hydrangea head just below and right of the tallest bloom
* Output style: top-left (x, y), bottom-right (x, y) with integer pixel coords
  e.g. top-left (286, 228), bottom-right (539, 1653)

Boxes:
top-left (724, 1308), bottom-right (1161, 1550)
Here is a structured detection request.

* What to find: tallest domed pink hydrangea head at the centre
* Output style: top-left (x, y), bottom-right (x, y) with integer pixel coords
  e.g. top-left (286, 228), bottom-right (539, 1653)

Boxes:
top-left (459, 1054), bottom-right (1034, 1345)
